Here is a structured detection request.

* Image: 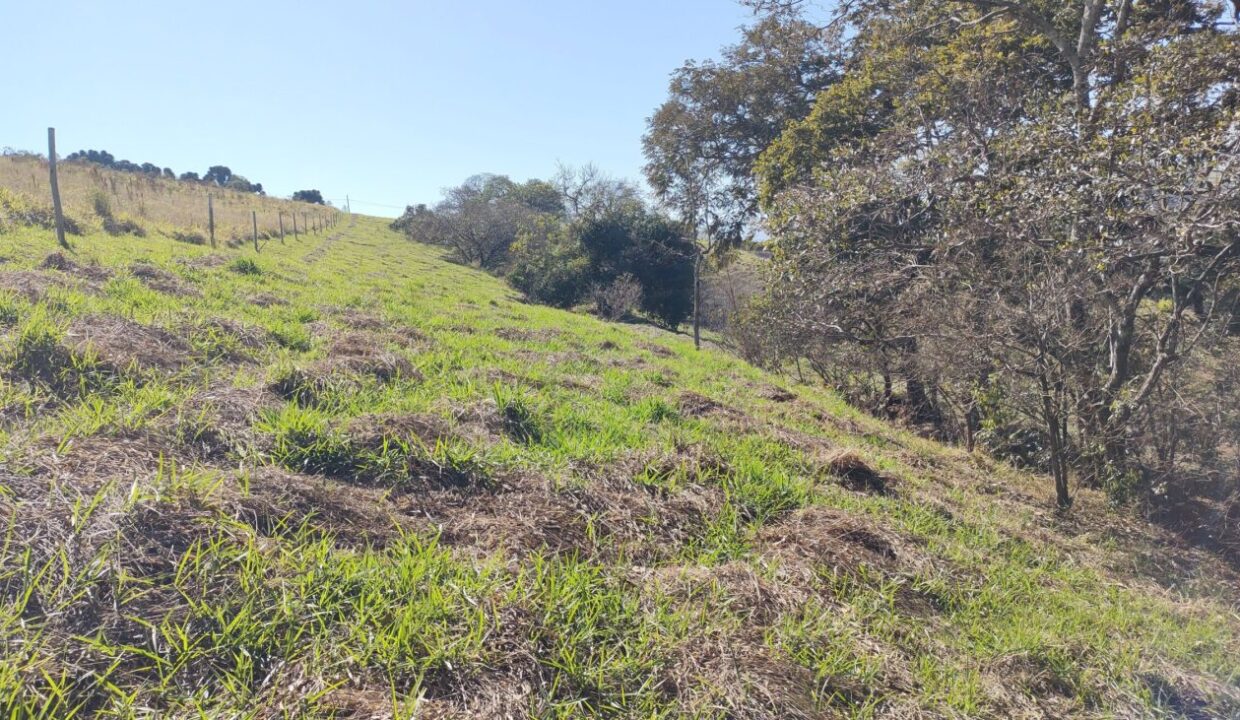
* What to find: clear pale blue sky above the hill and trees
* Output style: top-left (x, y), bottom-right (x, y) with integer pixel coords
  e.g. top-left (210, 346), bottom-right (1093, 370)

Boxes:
top-left (0, 0), bottom-right (750, 214)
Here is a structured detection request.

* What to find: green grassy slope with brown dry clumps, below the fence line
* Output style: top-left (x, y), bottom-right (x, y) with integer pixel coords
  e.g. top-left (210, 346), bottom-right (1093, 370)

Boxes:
top-left (0, 210), bottom-right (1240, 718)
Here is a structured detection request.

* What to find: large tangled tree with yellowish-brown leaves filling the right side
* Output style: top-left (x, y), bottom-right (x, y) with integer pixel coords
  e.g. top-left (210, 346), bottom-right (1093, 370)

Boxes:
top-left (756, 0), bottom-right (1240, 507)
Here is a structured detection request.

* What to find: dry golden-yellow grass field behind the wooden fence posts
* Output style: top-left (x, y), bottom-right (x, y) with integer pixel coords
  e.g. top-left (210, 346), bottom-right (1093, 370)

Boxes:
top-left (0, 155), bottom-right (334, 244)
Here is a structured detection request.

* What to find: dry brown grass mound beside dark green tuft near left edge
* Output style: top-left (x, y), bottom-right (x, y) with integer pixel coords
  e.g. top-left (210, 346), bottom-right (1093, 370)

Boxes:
top-left (66, 315), bottom-right (192, 374)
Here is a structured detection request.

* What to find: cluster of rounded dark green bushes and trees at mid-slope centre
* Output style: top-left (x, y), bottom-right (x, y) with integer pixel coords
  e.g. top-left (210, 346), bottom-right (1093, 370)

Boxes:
top-left (392, 166), bottom-right (699, 327)
